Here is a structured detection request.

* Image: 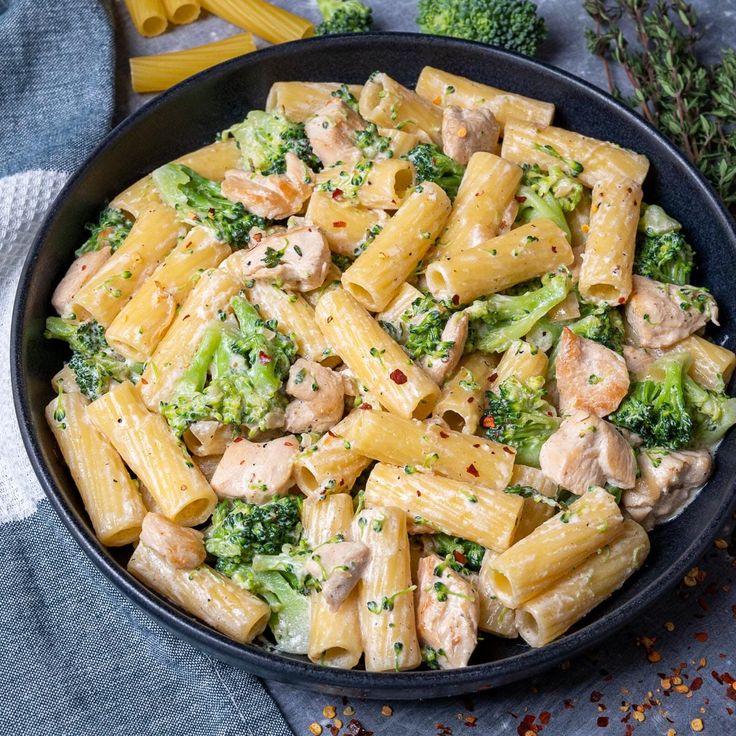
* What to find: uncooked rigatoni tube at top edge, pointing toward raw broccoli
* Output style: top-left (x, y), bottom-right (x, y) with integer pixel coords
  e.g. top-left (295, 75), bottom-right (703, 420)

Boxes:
top-left (200, 0), bottom-right (314, 43)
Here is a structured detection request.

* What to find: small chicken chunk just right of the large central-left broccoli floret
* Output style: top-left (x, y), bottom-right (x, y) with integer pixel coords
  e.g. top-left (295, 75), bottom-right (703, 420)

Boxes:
top-left (285, 358), bottom-right (345, 433)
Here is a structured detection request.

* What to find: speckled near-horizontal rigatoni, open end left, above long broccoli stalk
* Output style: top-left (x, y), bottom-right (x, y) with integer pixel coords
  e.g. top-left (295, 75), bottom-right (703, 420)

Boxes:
top-left (427, 219), bottom-right (573, 304)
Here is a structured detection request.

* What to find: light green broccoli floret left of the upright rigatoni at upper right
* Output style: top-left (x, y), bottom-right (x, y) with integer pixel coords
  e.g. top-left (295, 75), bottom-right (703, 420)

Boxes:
top-left (516, 164), bottom-right (583, 240)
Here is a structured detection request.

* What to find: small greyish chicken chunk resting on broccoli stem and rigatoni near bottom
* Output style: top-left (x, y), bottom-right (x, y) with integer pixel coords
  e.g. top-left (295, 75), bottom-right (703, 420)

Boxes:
top-left (305, 542), bottom-right (370, 611)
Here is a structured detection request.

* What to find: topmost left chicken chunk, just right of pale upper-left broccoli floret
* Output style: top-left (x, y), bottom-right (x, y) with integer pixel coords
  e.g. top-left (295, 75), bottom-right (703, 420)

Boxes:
top-left (304, 99), bottom-right (365, 166)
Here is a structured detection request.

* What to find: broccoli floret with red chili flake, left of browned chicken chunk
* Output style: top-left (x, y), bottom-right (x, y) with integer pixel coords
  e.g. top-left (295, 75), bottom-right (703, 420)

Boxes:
top-left (481, 376), bottom-right (561, 468)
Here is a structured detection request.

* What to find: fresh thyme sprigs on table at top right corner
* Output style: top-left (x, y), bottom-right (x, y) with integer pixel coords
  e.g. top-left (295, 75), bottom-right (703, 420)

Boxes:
top-left (583, 0), bottom-right (736, 210)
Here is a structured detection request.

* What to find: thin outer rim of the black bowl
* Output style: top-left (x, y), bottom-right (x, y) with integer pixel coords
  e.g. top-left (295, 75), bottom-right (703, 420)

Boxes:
top-left (10, 32), bottom-right (736, 699)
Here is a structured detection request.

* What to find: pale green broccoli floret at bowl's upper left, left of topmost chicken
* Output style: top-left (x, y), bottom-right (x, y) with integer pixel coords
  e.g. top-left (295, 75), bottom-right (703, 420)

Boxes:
top-left (222, 110), bottom-right (322, 176)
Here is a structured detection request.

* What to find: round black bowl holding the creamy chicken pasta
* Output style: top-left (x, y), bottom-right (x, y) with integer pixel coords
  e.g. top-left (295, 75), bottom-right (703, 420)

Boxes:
top-left (11, 34), bottom-right (736, 698)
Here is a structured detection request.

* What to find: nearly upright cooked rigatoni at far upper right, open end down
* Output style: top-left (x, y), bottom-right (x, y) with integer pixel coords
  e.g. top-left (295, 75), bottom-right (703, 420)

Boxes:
top-left (578, 179), bottom-right (642, 306)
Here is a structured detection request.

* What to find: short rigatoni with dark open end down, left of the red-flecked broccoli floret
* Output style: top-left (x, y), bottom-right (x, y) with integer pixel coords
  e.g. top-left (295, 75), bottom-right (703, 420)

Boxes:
top-left (432, 353), bottom-right (498, 435)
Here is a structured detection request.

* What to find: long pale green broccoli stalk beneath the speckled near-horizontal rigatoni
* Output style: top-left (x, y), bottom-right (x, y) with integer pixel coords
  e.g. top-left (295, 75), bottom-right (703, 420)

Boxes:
top-left (465, 269), bottom-right (572, 353)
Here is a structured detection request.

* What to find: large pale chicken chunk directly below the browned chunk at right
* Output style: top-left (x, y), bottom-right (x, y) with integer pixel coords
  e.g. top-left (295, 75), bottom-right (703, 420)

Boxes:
top-left (539, 412), bottom-right (636, 495)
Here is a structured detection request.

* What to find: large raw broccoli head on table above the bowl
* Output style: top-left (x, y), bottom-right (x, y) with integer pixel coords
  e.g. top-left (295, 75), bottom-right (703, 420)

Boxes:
top-left (417, 0), bottom-right (547, 56)
